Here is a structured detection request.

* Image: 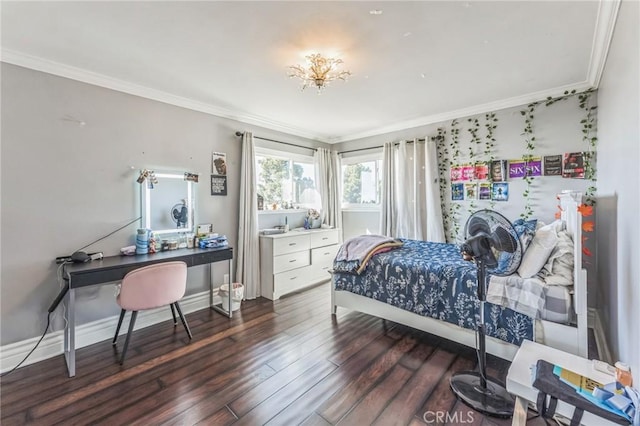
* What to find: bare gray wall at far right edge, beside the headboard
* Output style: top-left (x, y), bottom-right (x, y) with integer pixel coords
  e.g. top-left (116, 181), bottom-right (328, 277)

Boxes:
top-left (596, 0), bottom-right (640, 372)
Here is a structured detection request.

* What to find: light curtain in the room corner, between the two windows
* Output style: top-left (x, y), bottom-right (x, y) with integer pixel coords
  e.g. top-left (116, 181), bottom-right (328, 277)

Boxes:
top-left (313, 148), bottom-right (342, 233)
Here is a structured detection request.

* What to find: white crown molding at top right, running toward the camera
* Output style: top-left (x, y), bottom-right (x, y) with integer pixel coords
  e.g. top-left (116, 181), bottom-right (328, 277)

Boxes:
top-left (587, 0), bottom-right (621, 88)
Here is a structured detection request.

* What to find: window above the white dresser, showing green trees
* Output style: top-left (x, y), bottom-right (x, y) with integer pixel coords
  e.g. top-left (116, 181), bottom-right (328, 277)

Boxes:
top-left (256, 149), bottom-right (320, 210)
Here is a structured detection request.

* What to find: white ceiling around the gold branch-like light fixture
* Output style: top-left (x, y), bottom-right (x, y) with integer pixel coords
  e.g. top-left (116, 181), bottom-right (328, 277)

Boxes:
top-left (1, 1), bottom-right (619, 143)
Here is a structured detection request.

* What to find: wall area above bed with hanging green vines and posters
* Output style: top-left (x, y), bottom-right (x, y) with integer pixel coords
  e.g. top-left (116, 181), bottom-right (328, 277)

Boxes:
top-left (431, 90), bottom-right (597, 243)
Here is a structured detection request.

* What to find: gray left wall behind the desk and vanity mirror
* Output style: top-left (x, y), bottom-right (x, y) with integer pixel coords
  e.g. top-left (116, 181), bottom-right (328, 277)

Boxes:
top-left (0, 63), bottom-right (326, 345)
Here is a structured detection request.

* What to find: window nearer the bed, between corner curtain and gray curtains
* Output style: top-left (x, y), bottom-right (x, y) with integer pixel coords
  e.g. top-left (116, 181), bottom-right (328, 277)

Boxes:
top-left (342, 154), bottom-right (382, 209)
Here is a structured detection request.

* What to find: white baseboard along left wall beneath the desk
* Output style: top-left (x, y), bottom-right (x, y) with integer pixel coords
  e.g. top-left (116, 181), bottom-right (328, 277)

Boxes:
top-left (0, 291), bottom-right (220, 372)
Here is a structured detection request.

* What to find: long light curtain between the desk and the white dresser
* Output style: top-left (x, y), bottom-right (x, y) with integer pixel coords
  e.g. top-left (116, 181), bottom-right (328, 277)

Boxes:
top-left (235, 132), bottom-right (260, 299)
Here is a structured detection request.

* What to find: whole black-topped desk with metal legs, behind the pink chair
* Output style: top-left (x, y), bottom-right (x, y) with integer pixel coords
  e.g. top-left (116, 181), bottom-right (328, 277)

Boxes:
top-left (63, 247), bottom-right (233, 377)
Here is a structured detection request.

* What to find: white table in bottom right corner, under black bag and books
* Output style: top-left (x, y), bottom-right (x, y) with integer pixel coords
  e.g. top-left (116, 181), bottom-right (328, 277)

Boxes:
top-left (507, 340), bottom-right (615, 426)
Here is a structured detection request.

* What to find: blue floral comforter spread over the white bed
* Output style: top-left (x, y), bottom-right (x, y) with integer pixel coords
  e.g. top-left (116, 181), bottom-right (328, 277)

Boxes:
top-left (333, 239), bottom-right (533, 345)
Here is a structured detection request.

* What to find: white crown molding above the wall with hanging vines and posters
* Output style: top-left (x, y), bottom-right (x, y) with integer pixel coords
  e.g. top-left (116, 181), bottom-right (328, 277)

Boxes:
top-left (328, 81), bottom-right (593, 143)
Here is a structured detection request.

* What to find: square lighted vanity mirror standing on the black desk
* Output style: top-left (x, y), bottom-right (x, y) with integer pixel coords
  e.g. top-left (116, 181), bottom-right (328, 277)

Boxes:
top-left (140, 171), bottom-right (195, 234)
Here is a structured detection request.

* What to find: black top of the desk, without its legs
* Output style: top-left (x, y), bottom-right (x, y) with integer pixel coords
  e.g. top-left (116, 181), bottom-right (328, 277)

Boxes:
top-left (63, 247), bottom-right (233, 288)
